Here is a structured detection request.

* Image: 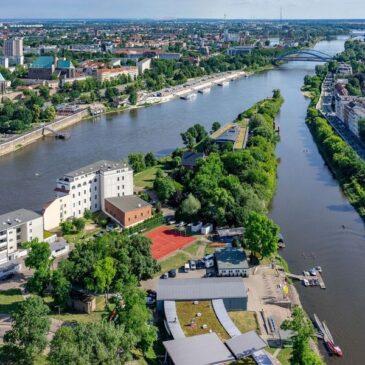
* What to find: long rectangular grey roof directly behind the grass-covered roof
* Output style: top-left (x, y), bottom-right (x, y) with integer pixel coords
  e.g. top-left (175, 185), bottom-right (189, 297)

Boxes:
top-left (157, 278), bottom-right (247, 301)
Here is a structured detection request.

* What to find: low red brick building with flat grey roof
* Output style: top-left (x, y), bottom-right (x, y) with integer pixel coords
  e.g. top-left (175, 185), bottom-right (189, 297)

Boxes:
top-left (105, 195), bottom-right (152, 228)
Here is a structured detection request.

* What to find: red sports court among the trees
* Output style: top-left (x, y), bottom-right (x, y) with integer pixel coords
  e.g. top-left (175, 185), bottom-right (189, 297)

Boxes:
top-left (145, 226), bottom-right (196, 260)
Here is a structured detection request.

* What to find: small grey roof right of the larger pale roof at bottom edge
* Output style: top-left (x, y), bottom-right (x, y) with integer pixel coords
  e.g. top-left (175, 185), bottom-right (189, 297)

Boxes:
top-left (226, 331), bottom-right (267, 359)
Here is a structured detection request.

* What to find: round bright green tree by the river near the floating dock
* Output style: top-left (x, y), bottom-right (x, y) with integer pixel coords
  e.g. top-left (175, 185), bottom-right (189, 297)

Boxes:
top-left (244, 212), bottom-right (279, 257)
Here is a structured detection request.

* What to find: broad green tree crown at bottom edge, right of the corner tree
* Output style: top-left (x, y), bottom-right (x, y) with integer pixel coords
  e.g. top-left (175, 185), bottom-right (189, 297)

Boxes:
top-left (48, 322), bottom-right (136, 365)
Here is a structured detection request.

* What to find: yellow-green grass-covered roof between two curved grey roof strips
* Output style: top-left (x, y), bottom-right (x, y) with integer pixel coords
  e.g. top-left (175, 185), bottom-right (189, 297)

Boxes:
top-left (176, 301), bottom-right (230, 340)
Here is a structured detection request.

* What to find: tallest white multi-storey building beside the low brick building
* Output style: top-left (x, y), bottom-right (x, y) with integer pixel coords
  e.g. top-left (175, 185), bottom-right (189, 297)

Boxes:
top-left (43, 160), bottom-right (133, 226)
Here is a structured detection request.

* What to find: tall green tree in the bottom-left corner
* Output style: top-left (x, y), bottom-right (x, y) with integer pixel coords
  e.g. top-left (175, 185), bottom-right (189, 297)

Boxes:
top-left (4, 296), bottom-right (51, 365)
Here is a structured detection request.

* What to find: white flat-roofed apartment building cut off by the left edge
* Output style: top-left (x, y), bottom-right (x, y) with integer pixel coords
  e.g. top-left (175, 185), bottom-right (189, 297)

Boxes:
top-left (0, 209), bottom-right (43, 264)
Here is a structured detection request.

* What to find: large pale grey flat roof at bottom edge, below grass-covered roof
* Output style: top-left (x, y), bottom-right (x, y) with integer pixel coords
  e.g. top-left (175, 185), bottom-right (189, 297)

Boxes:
top-left (163, 332), bottom-right (234, 365)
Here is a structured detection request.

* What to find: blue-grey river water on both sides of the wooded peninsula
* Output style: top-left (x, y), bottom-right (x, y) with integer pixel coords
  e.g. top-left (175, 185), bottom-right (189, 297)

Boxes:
top-left (0, 39), bottom-right (365, 365)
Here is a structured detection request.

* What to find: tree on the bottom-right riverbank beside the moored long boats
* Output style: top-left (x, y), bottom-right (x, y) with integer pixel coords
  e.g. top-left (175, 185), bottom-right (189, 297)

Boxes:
top-left (281, 306), bottom-right (324, 365)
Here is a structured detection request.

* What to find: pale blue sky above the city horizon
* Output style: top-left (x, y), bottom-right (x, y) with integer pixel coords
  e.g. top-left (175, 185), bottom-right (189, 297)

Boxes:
top-left (0, 0), bottom-right (365, 19)
